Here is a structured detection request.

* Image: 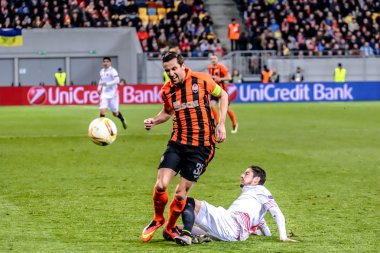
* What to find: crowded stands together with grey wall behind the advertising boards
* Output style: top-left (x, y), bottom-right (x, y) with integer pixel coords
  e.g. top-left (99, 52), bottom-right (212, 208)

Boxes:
top-left (0, 0), bottom-right (380, 86)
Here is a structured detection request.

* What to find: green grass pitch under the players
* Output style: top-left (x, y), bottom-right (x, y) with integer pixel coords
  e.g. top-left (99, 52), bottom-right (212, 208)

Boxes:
top-left (0, 103), bottom-right (380, 253)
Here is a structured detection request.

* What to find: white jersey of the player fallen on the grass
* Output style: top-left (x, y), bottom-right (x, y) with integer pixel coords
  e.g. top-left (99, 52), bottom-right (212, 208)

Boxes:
top-left (227, 185), bottom-right (286, 240)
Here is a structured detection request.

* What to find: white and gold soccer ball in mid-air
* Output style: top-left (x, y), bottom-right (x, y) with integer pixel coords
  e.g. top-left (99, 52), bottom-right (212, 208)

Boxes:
top-left (88, 117), bottom-right (117, 146)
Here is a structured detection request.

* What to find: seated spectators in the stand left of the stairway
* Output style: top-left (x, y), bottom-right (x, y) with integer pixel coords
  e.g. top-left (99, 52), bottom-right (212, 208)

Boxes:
top-left (0, 0), bottom-right (225, 57)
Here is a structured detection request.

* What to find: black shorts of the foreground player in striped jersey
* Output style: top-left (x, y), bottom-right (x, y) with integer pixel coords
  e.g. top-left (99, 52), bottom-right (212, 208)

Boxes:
top-left (158, 141), bottom-right (215, 182)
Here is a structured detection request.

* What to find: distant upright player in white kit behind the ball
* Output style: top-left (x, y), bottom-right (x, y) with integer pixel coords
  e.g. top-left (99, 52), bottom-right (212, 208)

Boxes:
top-left (98, 57), bottom-right (127, 129)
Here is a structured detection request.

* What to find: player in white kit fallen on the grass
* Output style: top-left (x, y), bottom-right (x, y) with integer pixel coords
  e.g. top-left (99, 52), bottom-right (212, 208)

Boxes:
top-left (175, 166), bottom-right (297, 245)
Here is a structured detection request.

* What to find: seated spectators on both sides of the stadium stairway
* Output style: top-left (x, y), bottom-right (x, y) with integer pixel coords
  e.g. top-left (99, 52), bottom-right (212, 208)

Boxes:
top-left (0, 0), bottom-right (380, 57)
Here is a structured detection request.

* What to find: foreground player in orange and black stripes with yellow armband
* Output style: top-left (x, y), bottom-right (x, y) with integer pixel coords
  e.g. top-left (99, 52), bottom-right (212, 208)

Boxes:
top-left (140, 52), bottom-right (228, 242)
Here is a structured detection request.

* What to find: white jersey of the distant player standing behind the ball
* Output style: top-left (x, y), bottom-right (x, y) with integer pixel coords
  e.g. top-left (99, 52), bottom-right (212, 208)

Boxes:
top-left (98, 66), bottom-right (120, 99)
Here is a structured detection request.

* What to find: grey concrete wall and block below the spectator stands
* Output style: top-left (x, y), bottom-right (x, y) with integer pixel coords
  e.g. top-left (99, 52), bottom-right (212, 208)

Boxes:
top-left (0, 28), bottom-right (380, 86)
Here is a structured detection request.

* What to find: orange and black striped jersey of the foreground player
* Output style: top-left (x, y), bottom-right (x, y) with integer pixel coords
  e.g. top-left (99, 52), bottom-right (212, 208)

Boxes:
top-left (161, 68), bottom-right (217, 146)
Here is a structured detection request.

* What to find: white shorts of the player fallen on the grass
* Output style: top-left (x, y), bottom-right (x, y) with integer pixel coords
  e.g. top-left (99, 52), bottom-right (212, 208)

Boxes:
top-left (195, 201), bottom-right (239, 241)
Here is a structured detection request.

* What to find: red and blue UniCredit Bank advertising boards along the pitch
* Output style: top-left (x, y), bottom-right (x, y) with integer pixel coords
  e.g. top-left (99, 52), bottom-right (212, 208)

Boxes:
top-left (0, 82), bottom-right (380, 105)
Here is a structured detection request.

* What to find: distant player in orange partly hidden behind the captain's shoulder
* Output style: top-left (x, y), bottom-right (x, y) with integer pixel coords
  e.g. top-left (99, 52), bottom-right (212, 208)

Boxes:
top-left (207, 55), bottom-right (239, 134)
